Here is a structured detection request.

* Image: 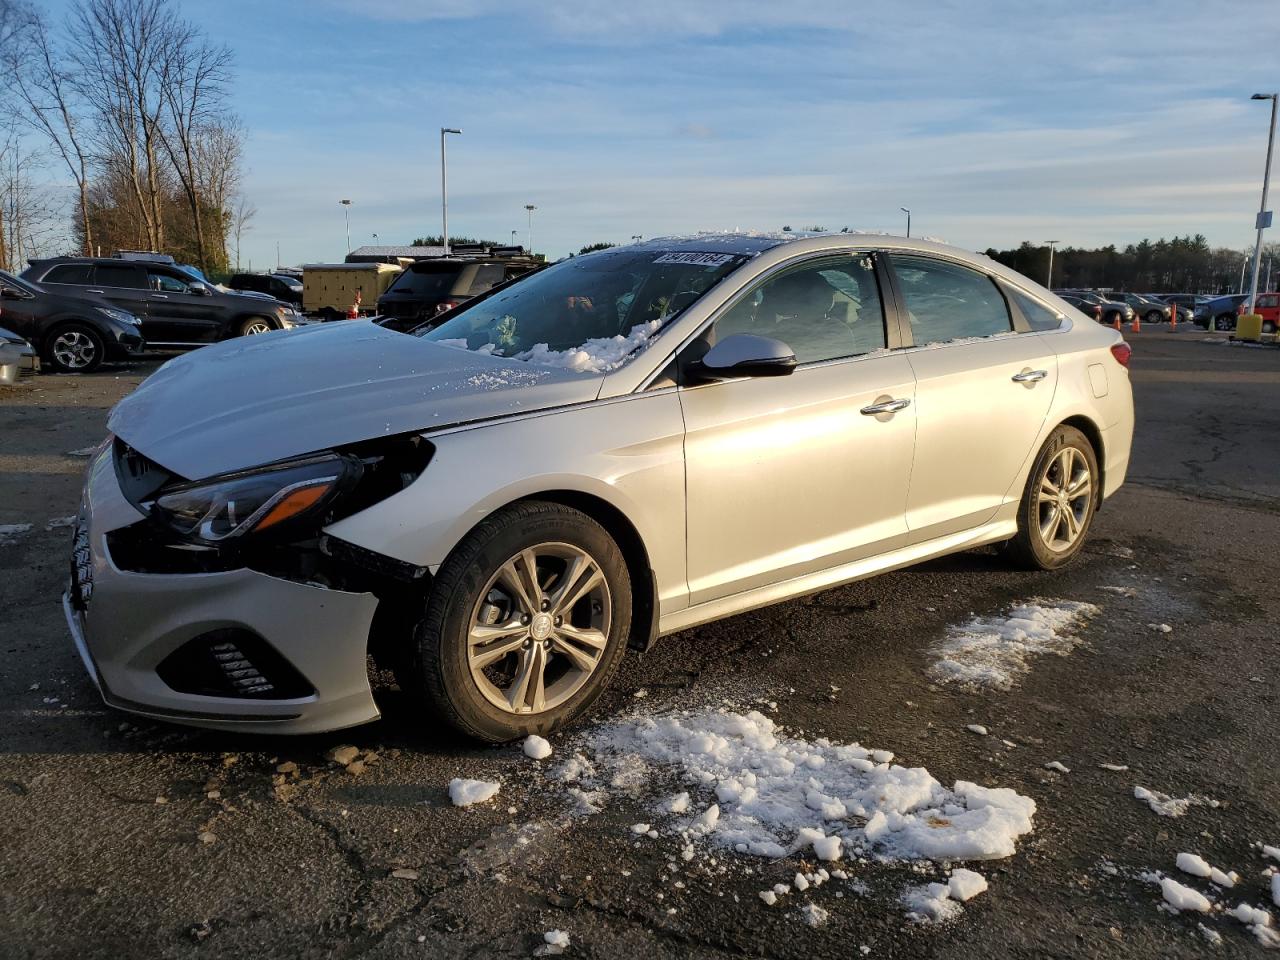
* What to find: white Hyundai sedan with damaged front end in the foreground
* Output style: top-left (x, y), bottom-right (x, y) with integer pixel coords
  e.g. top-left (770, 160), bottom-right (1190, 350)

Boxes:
top-left (64, 234), bottom-right (1134, 741)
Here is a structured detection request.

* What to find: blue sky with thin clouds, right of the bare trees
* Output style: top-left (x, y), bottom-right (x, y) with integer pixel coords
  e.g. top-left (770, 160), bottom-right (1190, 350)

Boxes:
top-left (45, 0), bottom-right (1280, 266)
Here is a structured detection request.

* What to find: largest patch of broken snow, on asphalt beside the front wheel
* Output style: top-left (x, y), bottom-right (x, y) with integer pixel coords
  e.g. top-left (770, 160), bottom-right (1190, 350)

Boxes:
top-left (556, 709), bottom-right (1036, 860)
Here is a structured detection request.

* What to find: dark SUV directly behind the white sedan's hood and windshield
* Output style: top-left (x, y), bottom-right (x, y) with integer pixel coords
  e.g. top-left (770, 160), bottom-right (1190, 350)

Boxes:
top-left (378, 256), bottom-right (543, 332)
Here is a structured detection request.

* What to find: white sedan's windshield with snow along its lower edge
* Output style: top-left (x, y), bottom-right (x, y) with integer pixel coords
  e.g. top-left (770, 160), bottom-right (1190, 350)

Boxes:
top-left (417, 248), bottom-right (746, 372)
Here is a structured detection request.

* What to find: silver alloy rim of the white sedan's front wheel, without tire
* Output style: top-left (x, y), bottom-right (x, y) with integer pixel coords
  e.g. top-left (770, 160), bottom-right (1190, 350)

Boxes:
top-left (467, 543), bottom-right (612, 714)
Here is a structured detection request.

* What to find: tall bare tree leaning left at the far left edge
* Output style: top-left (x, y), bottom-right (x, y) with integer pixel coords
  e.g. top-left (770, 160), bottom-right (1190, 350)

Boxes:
top-left (0, 1), bottom-right (93, 253)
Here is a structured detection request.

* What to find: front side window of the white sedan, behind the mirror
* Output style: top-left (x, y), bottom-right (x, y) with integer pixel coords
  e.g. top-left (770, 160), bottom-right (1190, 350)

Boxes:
top-left (714, 253), bottom-right (884, 364)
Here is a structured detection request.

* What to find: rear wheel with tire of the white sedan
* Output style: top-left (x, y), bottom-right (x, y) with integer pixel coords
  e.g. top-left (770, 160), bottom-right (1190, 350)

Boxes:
top-left (1006, 426), bottom-right (1101, 570)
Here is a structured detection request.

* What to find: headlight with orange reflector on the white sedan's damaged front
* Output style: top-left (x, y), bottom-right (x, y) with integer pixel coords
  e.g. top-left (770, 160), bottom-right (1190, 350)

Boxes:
top-left (151, 453), bottom-right (364, 543)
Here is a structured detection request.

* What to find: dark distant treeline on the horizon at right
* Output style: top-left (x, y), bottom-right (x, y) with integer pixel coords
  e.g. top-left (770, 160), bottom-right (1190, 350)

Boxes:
top-left (986, 233), bottom-right (1280, 293)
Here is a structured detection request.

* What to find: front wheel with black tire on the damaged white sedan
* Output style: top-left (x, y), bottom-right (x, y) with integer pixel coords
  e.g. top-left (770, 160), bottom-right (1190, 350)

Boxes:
top-left (399, 500), bottom-right (631, 744)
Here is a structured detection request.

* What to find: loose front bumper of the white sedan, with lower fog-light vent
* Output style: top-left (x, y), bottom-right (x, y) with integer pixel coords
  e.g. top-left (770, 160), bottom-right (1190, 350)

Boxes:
top-left (63, 445), bottom-right (379, 733)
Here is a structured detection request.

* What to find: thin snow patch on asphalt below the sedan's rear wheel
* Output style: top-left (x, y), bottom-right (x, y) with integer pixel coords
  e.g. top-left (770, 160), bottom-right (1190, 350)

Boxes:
top-left (929, 600), bottom-right (1098, 690)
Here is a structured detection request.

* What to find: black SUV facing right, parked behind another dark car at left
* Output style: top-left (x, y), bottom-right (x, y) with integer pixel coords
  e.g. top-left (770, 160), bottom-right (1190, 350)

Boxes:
top-left (22, 257), bottom-right (301, 347)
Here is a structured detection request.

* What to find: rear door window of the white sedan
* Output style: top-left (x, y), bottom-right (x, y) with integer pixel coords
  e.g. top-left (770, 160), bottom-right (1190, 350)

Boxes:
top-left (893, 256), bottom-right (1012, 346)
